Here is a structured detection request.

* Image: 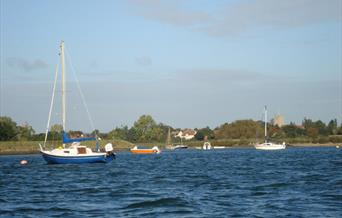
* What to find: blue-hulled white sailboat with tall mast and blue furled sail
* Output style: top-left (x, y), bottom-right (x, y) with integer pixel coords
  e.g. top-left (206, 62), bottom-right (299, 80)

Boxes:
top-left (39, 41), bottom-right (115, 164)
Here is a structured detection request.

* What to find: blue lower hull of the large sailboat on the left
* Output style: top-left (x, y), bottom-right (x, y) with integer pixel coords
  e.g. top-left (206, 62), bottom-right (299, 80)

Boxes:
top-left (42, 152), bottom-right (115, 164)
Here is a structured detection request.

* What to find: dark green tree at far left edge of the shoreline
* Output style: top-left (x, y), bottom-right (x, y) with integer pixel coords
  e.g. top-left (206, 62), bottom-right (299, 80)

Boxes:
top-left (0, 117), bottom-right (18, 141)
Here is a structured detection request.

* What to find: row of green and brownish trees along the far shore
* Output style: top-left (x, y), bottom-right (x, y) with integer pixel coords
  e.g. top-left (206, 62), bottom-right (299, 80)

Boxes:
top-left (0, 115), bottom-right (342, 143)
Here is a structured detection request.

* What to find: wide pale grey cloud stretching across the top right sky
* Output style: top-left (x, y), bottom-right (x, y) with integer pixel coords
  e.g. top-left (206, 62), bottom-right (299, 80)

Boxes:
top-left (131, 0), bottom-right (342, 37)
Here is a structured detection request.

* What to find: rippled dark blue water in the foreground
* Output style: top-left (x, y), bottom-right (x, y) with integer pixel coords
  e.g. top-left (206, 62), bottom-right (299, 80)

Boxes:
top-left (0, 148), bottom-right (342, 217)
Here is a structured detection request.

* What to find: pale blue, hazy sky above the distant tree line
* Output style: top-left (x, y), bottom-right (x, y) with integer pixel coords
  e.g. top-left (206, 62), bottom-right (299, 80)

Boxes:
top-left (0, 0), bottom-right (342, 132)
